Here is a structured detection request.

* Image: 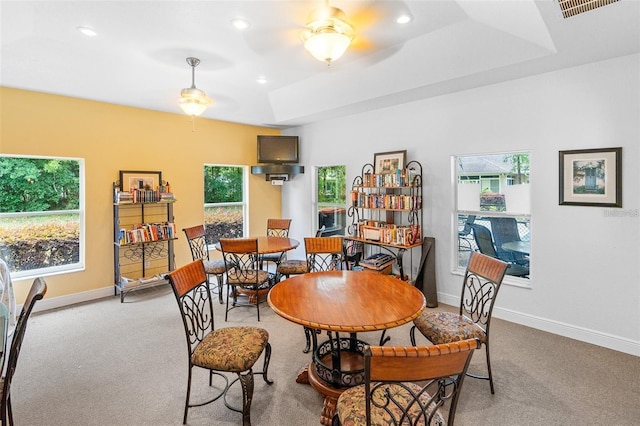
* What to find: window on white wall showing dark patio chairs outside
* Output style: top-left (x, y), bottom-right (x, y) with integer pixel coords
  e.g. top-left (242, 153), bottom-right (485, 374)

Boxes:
top-left (453, 152), bottom-right (531, 282)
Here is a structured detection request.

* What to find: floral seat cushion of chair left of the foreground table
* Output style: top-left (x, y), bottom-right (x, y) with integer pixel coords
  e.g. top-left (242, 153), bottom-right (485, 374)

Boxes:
top-left (191, 327), bottom-right (269, 372)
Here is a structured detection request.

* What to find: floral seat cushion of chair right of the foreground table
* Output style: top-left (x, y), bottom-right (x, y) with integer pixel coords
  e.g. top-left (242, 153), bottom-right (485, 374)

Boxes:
top-left (413, 311), bottom-right (487, 345)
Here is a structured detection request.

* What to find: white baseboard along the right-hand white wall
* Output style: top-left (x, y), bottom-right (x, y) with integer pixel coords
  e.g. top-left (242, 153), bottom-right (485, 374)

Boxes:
top-left (438, 293), bottom-right (640, 356)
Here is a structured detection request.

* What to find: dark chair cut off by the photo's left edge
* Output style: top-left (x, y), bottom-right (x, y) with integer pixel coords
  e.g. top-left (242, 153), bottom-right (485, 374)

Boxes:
top-left (0, 277), bottom-right (47, 425)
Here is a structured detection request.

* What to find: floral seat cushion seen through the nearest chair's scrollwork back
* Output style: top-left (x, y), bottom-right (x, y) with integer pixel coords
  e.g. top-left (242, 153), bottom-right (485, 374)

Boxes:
top-left (336, 383), bottom-right (447, 426)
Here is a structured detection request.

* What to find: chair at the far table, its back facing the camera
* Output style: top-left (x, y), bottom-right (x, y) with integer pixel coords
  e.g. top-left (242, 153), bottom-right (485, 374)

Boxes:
top-left (220, 238), bottom-right (272, 321)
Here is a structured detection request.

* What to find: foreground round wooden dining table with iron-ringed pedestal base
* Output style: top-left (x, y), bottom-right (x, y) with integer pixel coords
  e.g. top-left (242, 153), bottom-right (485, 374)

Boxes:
top-left (267, 271), bottom-right (426, 425)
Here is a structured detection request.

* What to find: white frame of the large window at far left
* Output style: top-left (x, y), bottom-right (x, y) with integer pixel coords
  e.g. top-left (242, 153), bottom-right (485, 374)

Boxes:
top-left (0, 154), bottom-right (86, 280)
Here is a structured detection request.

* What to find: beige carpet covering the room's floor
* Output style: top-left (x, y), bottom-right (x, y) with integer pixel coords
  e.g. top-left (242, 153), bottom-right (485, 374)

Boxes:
top-left (12, 286), bottom-right (640, 426)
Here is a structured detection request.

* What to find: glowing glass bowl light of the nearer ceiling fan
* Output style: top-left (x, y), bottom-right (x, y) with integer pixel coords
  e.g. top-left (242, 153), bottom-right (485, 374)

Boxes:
top-left (302, 6), bottom-right (354, 65)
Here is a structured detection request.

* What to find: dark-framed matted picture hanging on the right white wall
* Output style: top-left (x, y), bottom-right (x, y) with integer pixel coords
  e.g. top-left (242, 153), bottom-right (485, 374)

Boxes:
top-left (559, 148), bottom-right (622, 207)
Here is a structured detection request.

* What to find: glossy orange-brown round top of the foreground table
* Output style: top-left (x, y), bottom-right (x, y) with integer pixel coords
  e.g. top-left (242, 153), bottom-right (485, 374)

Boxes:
top-left (267, 271), bottom-right (425, 333)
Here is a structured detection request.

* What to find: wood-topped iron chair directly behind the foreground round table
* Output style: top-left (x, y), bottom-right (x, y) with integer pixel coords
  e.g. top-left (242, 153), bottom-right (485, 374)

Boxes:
top-left (302, 236), bottom-right (345, 353)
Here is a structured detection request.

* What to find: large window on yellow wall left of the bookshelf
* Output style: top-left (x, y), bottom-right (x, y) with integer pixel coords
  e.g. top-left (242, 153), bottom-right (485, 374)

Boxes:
top-left (0, 155), bottom-right (84, 278)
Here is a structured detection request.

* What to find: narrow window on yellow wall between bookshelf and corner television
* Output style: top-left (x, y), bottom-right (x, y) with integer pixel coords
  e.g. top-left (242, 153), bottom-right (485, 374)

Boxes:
top-left (204, 165), bottom-right (248, 245)
